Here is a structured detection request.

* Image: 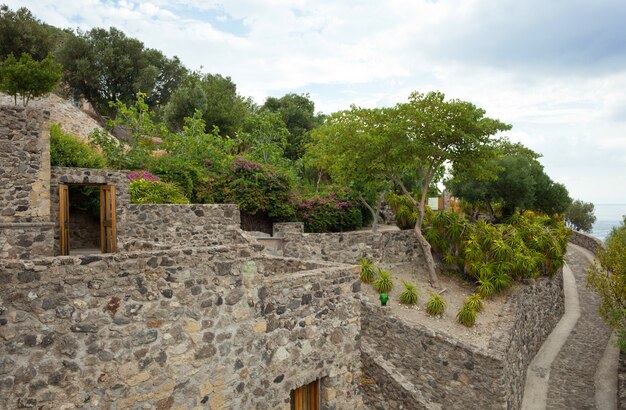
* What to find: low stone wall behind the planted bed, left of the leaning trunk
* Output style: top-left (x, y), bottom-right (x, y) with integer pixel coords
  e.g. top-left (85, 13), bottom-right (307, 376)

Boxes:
top-left (274, 223), bottom-right (424, 266)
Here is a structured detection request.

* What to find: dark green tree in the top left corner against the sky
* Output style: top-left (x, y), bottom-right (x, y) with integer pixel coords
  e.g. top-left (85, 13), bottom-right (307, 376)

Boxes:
top-left (0, 4), bottom-right (67, 60)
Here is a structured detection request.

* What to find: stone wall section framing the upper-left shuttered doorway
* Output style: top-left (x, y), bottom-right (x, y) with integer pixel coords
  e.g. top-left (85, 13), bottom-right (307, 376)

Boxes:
top-left (50, 167), bottom-right (130, 255)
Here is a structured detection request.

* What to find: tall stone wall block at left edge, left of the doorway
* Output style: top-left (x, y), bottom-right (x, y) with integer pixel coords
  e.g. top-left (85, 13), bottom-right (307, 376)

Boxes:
top-left (0, 106), bottom-right (50, 223)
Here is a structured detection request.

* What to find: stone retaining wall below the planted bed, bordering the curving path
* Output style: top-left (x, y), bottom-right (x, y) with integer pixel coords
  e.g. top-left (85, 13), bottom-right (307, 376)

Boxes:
top-left (361, 273), bottom-right (564, 409)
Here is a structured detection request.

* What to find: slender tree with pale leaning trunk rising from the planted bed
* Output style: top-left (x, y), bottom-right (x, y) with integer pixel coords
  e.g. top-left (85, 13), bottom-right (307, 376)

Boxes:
top-left (386, 92), bottom-right (511, 286)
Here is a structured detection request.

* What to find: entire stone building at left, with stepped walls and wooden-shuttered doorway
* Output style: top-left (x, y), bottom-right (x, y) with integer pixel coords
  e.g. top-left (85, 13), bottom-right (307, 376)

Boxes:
top-left (0, 107), bottom-right (363, 409)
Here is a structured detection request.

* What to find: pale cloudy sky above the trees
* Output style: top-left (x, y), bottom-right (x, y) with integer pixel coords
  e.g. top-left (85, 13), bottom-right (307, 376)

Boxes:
top-left (9, 0), bottom-right (626, 204)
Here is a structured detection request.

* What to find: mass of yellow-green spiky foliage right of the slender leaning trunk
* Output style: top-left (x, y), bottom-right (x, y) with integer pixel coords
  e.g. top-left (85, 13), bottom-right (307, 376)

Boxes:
top-left (424, 211), bottom-right (569, 298)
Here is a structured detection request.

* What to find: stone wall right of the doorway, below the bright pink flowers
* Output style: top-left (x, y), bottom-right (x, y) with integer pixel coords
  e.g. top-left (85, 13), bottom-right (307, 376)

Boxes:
top-left (128, 204), bottom-right (251, 246)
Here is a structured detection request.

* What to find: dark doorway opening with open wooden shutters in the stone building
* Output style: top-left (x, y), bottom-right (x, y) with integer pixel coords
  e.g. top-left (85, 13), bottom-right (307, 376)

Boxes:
top-left (59, 184), bottom-right (117, 255)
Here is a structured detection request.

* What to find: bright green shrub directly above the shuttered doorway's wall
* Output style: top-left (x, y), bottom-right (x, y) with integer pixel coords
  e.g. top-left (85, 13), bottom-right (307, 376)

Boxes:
top-left (50, 124), bottom-right (106, 169)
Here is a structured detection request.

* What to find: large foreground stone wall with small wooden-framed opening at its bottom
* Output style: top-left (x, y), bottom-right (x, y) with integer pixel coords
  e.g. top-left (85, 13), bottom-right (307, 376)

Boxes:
top-left (0, 246), bottom-right (363, 409)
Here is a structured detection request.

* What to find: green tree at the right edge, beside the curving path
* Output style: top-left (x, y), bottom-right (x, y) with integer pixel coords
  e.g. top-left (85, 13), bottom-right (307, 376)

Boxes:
top-left (587, 217), bottom-right (626, 352)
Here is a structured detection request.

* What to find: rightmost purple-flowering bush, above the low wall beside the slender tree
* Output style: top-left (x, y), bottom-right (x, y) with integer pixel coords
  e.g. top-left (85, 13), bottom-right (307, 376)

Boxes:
top-left (291, 192), bottom-right (363, 232)
